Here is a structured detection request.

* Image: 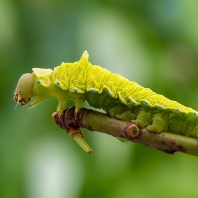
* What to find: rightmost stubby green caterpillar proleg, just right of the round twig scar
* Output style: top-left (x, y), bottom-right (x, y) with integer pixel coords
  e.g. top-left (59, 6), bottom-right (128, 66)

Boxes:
top-left (146, 114), bottom-right (168, 133)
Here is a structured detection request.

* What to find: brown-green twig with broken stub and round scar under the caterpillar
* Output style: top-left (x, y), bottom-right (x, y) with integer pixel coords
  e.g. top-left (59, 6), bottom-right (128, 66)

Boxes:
top-left (52, 107), bottom-right (198, 155)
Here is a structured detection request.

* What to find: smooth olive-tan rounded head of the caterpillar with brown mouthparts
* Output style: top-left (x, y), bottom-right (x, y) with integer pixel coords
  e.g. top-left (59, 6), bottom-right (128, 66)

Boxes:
top-left (14, 73), bottom-right (34, 106)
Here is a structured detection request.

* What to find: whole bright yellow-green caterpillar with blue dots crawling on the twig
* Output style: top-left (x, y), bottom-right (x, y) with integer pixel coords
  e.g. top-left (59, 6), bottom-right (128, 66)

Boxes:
top-left (14, 51), bottom-right (198, 138)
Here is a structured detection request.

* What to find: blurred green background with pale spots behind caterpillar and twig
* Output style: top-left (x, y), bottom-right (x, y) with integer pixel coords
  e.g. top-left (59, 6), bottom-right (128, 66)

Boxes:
top-left (0, 0), bottom-right (198, 198)
